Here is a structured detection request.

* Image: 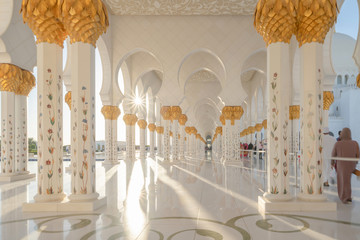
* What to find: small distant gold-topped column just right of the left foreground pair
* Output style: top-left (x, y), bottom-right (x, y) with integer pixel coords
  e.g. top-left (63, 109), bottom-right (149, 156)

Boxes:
top-left (101, 105), bottom-right (120, 164)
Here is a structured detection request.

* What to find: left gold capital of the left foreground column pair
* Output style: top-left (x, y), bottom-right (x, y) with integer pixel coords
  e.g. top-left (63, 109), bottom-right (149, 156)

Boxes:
top-left (20, 0), bottom-right (68, 47)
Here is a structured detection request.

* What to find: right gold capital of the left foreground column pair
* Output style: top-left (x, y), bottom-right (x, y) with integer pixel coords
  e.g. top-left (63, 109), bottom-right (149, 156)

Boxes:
top-left (61, 0), bottom-right (109, 47)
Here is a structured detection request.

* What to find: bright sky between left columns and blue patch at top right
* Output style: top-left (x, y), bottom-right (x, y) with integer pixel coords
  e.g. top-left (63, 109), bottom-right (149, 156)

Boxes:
top-left (7, 0), bottom-right (359, 145)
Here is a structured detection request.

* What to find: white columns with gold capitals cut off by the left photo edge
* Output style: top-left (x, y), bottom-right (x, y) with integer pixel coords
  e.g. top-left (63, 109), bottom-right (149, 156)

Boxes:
top-left (0, 63), bottom-right (35, 182)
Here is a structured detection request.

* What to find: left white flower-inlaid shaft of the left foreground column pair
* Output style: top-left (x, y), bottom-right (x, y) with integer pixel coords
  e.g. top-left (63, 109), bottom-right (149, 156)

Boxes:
top-left (34, 43), bottom-right (65, 202)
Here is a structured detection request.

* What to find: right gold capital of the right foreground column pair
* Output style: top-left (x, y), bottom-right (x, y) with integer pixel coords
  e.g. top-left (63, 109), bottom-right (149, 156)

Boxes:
top-left (296, 0), bottom-right (337, 47)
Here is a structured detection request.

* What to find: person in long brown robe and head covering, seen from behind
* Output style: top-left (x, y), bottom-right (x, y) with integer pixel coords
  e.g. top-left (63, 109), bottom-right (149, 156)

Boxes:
top-left (332, 128), bottom-right (360, 203)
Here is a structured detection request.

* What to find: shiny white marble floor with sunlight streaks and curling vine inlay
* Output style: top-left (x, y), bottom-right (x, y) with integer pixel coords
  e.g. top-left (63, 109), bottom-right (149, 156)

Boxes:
top-left (0, 155), bottom-right (360, 240)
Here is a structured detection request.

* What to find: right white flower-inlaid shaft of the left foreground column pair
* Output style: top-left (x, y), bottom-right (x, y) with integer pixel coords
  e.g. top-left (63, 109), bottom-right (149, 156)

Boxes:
top-left (69, 42), bottom-right (99, 201)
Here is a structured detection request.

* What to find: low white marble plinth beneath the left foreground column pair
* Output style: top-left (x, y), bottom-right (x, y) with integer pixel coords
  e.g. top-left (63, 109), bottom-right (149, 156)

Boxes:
top-left (22, 197), bottom-right (106, 212)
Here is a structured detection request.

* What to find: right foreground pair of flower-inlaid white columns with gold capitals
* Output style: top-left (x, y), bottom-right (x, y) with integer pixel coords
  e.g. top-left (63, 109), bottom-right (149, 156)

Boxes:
top-left (255, 1), bottom-right (337, 207)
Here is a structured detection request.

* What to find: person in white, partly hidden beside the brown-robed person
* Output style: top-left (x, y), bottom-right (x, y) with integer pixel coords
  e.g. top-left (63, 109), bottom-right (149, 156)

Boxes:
top-left (323, 127), bottom-right (336, 187)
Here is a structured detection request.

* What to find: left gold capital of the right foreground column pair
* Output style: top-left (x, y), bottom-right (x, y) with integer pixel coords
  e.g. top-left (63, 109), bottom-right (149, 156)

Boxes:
top-left (254, 0), bottom-right (298, 45)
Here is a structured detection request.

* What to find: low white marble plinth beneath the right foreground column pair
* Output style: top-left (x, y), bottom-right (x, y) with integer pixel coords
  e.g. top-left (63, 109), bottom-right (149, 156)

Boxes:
top-left (258, 196), bottom-right (337, 213)
